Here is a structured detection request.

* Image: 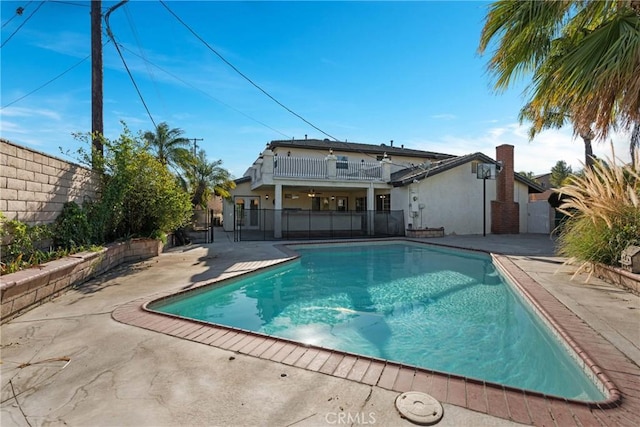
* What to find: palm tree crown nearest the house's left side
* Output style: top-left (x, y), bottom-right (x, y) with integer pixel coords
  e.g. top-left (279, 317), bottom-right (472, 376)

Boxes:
top-left (187, 150), bottom-right (235, 208)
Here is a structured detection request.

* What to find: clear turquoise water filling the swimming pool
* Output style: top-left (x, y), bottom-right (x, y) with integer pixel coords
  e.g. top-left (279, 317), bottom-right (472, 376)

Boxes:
top-left (152, 243), bottom-right (605, 401)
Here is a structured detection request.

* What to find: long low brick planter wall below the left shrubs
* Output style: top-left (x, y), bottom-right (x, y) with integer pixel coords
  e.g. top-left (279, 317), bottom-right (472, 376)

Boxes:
top-left (0, 239), bottom-right (162, 323)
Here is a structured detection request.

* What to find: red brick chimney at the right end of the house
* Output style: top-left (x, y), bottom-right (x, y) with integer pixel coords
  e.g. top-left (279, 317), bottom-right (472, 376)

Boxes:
top-left (491, 144), bottom-right (520, 234)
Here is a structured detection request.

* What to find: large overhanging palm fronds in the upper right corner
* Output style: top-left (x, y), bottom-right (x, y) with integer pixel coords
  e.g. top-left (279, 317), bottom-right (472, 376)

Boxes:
top-left (479, 0), bottom-right (640, 161)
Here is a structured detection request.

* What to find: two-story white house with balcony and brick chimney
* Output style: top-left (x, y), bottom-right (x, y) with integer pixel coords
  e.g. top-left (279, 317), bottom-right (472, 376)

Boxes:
top-left (223, 138), bottom-right (541, 239)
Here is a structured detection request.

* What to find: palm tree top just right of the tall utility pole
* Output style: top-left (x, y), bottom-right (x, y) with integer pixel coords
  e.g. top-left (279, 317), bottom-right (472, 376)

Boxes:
top-left (142, 122), bottom-right (193, 169)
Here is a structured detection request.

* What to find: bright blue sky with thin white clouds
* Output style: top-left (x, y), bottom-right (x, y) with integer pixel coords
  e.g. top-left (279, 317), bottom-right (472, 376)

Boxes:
top-left (0, 0), bottom-right (629, 178)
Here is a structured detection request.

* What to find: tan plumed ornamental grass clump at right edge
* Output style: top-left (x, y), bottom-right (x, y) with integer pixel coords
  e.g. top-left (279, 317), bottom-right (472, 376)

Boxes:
top-left (555, 143), bottom-right (640, 271)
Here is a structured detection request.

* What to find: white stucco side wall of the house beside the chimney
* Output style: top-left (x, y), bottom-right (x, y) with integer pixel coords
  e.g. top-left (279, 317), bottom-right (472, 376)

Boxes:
top-left (404, 163), bottom-right (496, 234)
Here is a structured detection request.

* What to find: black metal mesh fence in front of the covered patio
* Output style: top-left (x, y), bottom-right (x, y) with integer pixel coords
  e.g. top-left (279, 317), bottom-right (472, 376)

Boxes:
top-left (234, 209), bottom-right (405, 241)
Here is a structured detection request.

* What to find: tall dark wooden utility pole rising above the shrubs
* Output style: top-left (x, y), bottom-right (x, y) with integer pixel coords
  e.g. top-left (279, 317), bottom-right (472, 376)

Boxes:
top-left (91, 0), bottom-right (104, 168)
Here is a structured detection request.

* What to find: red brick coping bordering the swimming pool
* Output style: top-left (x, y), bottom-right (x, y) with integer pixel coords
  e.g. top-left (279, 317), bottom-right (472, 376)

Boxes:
top-left (112, 246), bottom-right (640, 427)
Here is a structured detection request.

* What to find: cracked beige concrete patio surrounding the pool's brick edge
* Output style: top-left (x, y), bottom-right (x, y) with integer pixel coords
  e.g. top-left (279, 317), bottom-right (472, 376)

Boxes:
top-left (0, 229), bottom-right (640, 427)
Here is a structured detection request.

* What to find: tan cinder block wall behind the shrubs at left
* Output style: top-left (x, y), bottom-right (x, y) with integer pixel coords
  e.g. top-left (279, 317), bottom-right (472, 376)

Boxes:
top-left (0, 139), bottom-right (99, 225)
